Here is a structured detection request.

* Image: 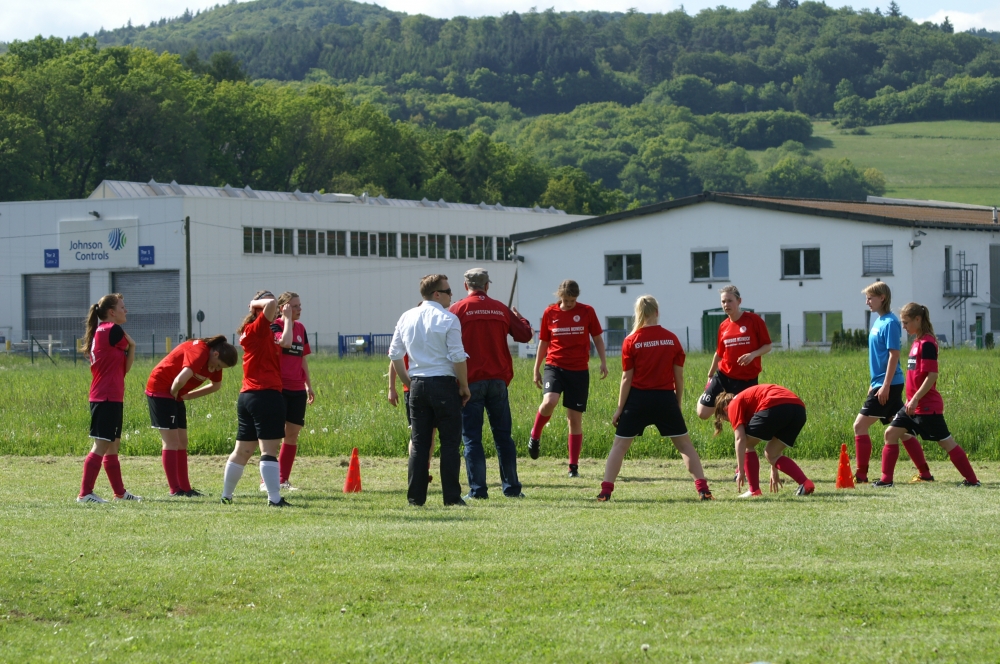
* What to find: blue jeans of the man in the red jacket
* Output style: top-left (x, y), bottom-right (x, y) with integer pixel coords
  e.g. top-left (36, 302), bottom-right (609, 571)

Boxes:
top-left (462, 379), bottom-right (521, 498)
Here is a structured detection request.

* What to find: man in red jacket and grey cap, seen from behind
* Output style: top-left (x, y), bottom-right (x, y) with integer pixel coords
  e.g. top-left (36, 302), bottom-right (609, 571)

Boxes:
top-left (450, 268), bottom-right (534, 499)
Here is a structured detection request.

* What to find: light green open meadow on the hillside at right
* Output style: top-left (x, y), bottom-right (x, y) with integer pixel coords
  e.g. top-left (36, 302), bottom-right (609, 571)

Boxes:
top-left (807, 120), bottom-right (1000, 205)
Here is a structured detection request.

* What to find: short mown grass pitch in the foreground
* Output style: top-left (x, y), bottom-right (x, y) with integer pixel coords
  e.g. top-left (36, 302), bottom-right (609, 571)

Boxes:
top-left (0, 457), bottom-right (1000, 664)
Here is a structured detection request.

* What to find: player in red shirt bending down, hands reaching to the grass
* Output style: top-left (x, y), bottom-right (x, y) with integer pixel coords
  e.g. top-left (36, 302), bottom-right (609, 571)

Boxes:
top-left (715, 385), bottom-right (816, 498)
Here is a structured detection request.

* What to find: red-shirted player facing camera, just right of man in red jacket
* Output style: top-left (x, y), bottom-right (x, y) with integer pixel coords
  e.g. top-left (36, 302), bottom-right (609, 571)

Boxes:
top-left (528, 279), bottom-right (608, 477)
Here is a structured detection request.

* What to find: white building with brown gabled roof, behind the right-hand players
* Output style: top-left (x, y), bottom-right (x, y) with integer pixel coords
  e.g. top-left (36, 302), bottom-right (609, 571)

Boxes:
top-left (512, 193), bottom-right (1000, 350)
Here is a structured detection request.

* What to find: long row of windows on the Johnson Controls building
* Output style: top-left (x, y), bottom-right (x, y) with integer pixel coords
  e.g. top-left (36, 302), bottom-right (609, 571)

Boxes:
top-left (243, 226), bottom-right (514, 261)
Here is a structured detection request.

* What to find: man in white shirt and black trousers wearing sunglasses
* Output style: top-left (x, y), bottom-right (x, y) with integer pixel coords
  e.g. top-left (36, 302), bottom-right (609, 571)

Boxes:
top-left (389, 274), bottom-right (470, 505)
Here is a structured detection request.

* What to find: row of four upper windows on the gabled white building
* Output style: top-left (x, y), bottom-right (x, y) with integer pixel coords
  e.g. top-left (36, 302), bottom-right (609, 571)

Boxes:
top-left (604, 242), bottom-right (892, 284)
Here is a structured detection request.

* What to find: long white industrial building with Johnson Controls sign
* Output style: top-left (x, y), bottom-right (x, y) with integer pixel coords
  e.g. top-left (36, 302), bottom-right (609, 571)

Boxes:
top-left (0, 176), bottom-right (585, 353)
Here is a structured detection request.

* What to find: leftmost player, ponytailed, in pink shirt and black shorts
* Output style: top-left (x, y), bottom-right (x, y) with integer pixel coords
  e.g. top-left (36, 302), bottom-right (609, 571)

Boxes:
top-left (76, 293), bottom-right (142, 503)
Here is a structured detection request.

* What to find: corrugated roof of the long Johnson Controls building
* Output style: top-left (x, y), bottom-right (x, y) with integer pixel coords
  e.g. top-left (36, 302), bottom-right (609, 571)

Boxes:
top-left (90, 180), bottom-right (566, 215)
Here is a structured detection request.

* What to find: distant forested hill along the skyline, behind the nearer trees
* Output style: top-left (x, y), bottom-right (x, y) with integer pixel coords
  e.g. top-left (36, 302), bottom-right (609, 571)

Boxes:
top-left (88, 0), bottom-right (1000, 115)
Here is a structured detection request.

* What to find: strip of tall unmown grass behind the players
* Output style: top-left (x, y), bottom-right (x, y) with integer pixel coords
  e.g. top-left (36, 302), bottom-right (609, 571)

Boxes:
top-left (0, 349), bottom-right (1000, 459)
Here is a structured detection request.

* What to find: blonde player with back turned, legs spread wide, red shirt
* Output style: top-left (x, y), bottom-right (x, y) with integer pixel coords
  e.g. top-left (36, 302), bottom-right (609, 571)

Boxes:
top-left (597, 295), bottom-right (713, 502)
